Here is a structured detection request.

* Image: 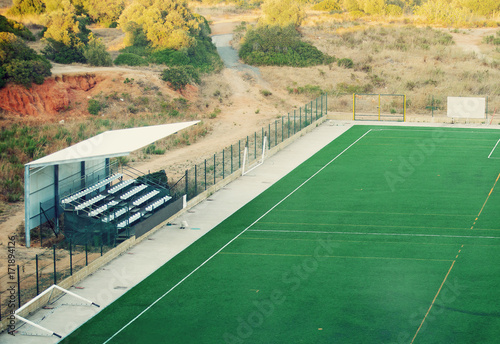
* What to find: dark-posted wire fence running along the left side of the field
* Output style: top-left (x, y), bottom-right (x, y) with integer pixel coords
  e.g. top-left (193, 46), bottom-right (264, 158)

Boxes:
top-left (0, 94), bottom-right (327, 321)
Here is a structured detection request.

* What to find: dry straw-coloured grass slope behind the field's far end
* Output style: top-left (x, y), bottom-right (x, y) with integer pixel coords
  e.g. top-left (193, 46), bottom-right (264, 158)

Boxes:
top-left (263, 17), bottom-right (500, 114)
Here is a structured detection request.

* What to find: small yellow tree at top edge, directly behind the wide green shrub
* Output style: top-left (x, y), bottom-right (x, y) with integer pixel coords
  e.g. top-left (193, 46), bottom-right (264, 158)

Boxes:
top-left (259, 0), bottom-right (306, 27)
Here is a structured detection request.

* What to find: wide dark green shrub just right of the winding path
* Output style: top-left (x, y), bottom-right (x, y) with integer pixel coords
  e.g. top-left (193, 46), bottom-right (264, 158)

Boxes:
top-left (239, 26), bottom-right (334, 67)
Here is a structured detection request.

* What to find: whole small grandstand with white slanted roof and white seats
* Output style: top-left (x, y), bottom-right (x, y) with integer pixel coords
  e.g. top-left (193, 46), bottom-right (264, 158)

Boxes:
top-left (24, 121), bottom-right (199, 247)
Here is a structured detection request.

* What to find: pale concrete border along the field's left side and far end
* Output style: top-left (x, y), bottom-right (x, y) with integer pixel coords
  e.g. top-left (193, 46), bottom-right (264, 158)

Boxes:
top-left (0, 115), bottom-right (500, 344)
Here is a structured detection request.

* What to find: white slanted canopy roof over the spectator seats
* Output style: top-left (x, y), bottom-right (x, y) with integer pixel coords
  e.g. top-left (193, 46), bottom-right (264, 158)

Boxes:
top-left (26, 121), bottom-right (199, 167)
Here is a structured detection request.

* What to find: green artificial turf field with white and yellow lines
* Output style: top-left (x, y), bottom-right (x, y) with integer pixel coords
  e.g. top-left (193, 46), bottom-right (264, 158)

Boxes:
top-left (62, 126), bottom-right (500, 344)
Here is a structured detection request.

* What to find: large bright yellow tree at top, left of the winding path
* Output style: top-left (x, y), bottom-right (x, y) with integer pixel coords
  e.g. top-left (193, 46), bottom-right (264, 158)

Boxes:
top-left (118, 0), bottom-right (201, 50)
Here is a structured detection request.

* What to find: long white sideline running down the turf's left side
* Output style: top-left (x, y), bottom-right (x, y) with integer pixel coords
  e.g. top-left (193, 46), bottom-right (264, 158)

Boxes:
top-left (103, 129), bottom-right (372, 344)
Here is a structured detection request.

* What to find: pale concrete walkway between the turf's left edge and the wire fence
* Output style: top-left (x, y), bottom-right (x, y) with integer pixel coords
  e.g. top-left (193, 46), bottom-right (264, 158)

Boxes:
top-left (0, 120), bottom-right (352, 344)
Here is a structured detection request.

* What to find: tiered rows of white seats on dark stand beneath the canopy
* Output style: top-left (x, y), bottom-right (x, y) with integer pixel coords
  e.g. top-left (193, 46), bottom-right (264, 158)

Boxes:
top-left (61, 169), bottom-right (172, 245)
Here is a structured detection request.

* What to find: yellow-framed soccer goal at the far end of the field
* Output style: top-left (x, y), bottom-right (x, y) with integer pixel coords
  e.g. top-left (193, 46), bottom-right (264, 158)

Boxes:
top-left (352, 93), bottom-right (406, 122)
